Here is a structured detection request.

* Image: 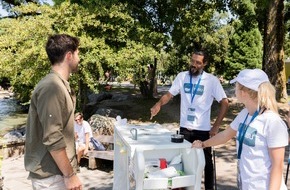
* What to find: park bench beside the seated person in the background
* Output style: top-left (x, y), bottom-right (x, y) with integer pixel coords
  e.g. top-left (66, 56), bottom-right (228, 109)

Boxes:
top-left (85, 135), bottom-right (114, 169)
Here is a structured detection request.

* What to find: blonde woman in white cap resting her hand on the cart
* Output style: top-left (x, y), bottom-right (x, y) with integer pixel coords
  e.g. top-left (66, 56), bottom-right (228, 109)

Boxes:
top-left (192, 69), bottom-right (288, 190)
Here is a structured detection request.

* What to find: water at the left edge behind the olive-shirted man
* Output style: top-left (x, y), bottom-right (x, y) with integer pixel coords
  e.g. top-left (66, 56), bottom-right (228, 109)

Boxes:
top-left (0, 99), bottom-right (27, 135)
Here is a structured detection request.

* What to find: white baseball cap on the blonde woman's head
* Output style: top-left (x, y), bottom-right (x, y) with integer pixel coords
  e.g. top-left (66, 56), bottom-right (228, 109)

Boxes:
top-left (230, 69), bottom-right (269, 91)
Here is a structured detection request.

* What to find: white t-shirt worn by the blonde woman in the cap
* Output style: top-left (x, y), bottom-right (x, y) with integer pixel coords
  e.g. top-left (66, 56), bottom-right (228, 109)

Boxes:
top-left (230, 109), bottom-right (288, 190)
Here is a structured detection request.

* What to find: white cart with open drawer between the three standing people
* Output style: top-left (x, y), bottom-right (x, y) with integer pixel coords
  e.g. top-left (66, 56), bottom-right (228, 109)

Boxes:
top-left (113, 124), bottom-right (205, 190)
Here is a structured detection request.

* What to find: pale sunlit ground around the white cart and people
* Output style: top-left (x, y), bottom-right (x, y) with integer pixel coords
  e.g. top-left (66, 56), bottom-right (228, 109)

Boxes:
top-left (2, 140), bottom-right (290, 190)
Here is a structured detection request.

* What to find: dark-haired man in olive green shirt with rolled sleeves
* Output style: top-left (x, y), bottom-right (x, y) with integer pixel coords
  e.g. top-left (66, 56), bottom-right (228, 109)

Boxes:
top-left (24, 34), bottom-right (82, 190)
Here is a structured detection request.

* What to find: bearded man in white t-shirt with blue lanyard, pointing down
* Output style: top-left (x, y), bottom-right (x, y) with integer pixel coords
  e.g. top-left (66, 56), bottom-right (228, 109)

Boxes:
top-left (151, 51), bottom-right (228, 190)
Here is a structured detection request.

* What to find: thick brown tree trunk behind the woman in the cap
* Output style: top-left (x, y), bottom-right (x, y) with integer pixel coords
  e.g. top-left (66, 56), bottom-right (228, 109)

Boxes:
top-left (263, 0), bottom-right (288, 102)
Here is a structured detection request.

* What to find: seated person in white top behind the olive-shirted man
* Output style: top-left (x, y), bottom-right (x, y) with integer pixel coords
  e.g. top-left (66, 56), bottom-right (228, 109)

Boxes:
top-left (74, 112), bottom-right (93, 164)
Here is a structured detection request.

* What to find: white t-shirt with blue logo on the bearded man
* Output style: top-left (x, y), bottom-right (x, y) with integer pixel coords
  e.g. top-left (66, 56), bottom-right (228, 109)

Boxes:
top-left (169, 71), bottom-right (227, 131)
